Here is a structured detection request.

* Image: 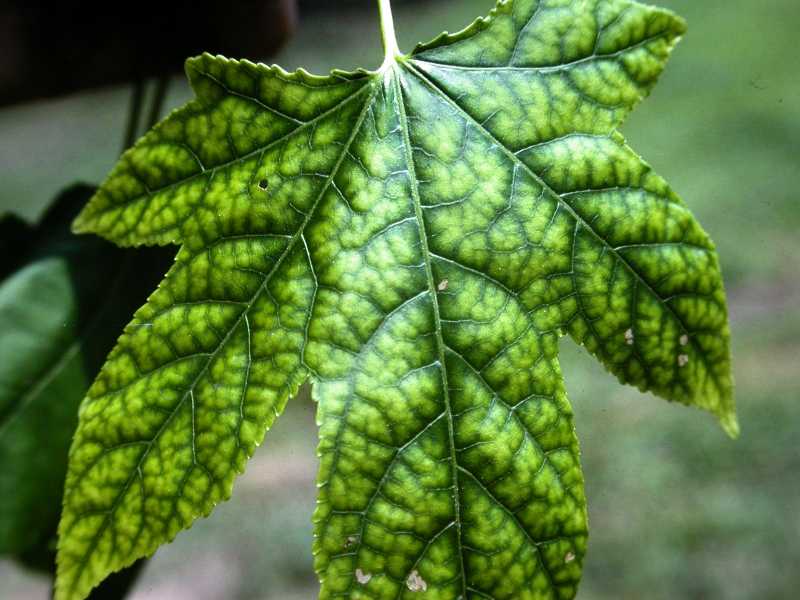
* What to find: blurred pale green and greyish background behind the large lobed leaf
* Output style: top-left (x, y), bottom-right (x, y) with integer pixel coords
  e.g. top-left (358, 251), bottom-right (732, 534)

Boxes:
top-left (0, 0), bottom-right (800, 600)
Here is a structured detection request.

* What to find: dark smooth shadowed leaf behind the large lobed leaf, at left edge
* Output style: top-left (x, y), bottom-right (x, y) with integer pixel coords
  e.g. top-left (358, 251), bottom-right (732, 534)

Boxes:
top-left (0, 185), bottom-right (170, 563)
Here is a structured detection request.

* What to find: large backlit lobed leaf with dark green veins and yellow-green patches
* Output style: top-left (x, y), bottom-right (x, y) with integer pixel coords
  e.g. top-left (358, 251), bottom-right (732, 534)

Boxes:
top-left (57, 0), bottom-right (736, 600)
